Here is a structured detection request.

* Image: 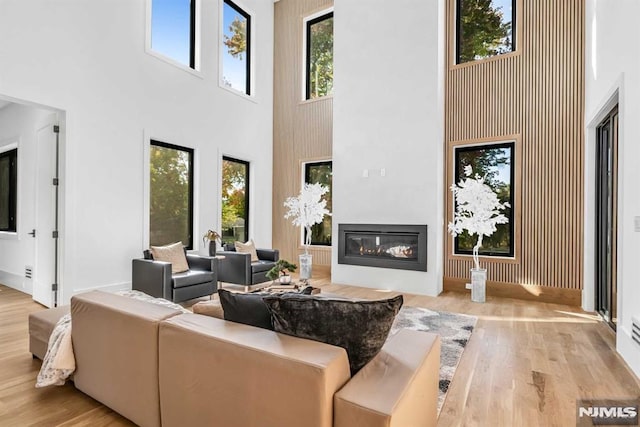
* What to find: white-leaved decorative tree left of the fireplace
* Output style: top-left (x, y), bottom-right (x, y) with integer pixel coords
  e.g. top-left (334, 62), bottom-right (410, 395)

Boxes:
top-left (284, 184), bottom-right (331, 254)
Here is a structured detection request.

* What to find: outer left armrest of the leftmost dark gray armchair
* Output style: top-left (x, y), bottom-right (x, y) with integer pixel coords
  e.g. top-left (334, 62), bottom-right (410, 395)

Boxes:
top-left (131, 259), bottom-right (173, 301)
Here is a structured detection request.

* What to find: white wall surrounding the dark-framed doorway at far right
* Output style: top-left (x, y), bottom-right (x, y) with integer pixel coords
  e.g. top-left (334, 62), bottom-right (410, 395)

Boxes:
top-left (584, 0), bottom-right (640, 376)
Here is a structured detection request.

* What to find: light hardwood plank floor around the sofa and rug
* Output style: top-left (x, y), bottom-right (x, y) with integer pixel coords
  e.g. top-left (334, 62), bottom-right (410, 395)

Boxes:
top-left (0, 279), bottom-right (640, 427)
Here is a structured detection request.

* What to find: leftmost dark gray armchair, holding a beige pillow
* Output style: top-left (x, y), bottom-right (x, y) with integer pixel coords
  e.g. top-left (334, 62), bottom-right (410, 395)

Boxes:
top-left (132, 251), bottom-right (218, 302)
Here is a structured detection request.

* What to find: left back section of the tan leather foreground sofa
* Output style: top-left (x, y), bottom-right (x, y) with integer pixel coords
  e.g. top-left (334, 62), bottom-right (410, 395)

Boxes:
top-left (71, 291), bottom-right (180, 427)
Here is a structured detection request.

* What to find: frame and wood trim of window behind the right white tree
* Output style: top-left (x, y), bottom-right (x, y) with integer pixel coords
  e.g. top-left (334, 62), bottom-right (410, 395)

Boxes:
top-left (445, 140), bottom-right (522, 264)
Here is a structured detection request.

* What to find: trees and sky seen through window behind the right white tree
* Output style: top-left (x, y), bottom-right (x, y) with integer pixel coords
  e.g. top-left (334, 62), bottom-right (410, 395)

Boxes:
top-left (456, 147), bottom-right (513, 255)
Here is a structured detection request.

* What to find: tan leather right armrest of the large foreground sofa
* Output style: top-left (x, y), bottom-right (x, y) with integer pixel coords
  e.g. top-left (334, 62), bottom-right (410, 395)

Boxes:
top-left (334, 329), bottom-right (440, 427)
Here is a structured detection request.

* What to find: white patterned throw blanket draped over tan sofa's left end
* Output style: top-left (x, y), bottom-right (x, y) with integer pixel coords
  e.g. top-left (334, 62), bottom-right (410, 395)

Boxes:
top-left (36, 291), bottom-right (190, 388)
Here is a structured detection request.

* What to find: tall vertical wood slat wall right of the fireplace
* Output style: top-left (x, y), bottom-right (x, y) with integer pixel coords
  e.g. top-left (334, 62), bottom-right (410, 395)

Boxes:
top-left (444, 0), bottom-right (590, 289)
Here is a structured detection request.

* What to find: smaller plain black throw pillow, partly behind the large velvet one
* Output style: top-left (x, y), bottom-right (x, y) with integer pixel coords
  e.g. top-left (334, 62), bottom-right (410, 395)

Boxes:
top-left (218, 289), bottom-right (273, 330)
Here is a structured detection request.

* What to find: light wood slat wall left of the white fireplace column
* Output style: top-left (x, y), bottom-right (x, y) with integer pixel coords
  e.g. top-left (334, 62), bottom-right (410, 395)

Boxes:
top-left (273, 0), bottom-right (333, 266)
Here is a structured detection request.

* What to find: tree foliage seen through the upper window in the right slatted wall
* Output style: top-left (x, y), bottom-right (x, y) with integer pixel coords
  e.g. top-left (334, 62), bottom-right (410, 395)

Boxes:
top-left (458, 0), bottom-right (512, 63)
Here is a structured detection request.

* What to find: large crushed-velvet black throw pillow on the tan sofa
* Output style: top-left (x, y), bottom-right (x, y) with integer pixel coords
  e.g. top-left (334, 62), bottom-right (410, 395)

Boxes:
top-left (264, 294), bottom-right (403, 375)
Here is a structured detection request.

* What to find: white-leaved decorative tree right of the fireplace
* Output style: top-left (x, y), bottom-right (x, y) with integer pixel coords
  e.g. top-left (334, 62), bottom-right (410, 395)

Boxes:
top-left (448, 166), bottom-right (509, 269)
